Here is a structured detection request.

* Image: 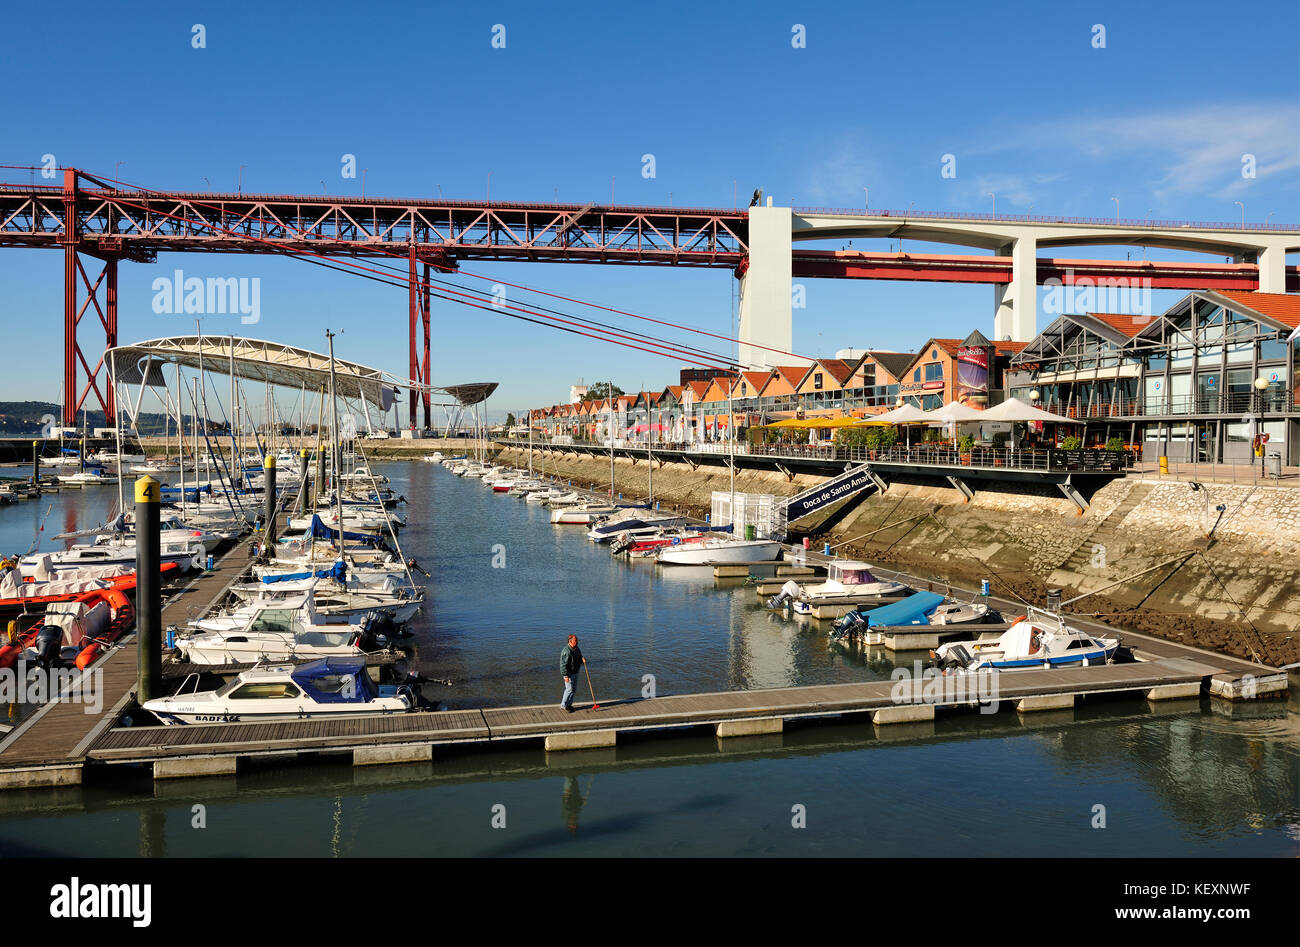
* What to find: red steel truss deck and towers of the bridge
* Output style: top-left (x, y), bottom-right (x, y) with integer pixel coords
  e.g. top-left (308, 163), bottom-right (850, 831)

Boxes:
top-left (0, 168), bottom-right (1300, 427)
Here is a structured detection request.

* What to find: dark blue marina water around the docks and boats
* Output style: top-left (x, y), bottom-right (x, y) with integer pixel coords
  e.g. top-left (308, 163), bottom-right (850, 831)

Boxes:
top-left (0, 463), bottom-right (1300, 856)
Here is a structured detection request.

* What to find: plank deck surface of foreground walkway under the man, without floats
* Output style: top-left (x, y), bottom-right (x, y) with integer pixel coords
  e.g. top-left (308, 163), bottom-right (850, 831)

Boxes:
top-left (86, 658), bottom-right (1217, 762)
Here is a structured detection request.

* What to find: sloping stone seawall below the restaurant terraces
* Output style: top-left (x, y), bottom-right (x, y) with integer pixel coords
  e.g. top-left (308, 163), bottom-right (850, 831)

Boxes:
top-left (491, 450), bottom-right (1300, 666)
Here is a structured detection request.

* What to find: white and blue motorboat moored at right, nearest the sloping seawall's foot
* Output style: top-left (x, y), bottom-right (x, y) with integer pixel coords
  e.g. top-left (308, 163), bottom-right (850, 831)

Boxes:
top-left (933, 609), bottom-right (1119, 671)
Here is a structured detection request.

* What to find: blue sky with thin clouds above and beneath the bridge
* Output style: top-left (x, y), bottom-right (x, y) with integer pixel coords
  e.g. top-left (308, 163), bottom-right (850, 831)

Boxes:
top-left (0, 1), bottom-right (1300, 421)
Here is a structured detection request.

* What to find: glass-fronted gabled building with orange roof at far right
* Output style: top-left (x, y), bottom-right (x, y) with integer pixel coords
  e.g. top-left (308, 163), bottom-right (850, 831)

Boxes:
top-left (1008, 290), bottom-right (1300, 464)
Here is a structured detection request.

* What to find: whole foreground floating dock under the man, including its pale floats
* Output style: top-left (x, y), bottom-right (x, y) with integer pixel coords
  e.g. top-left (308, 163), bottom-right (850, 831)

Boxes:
top-left (86, 658), bottom-right (1216, 778)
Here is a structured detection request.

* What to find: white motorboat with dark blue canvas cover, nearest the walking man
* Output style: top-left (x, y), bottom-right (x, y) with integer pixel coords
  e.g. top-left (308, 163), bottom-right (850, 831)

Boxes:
top-left (143, 658), bottom-right (419, 726)
